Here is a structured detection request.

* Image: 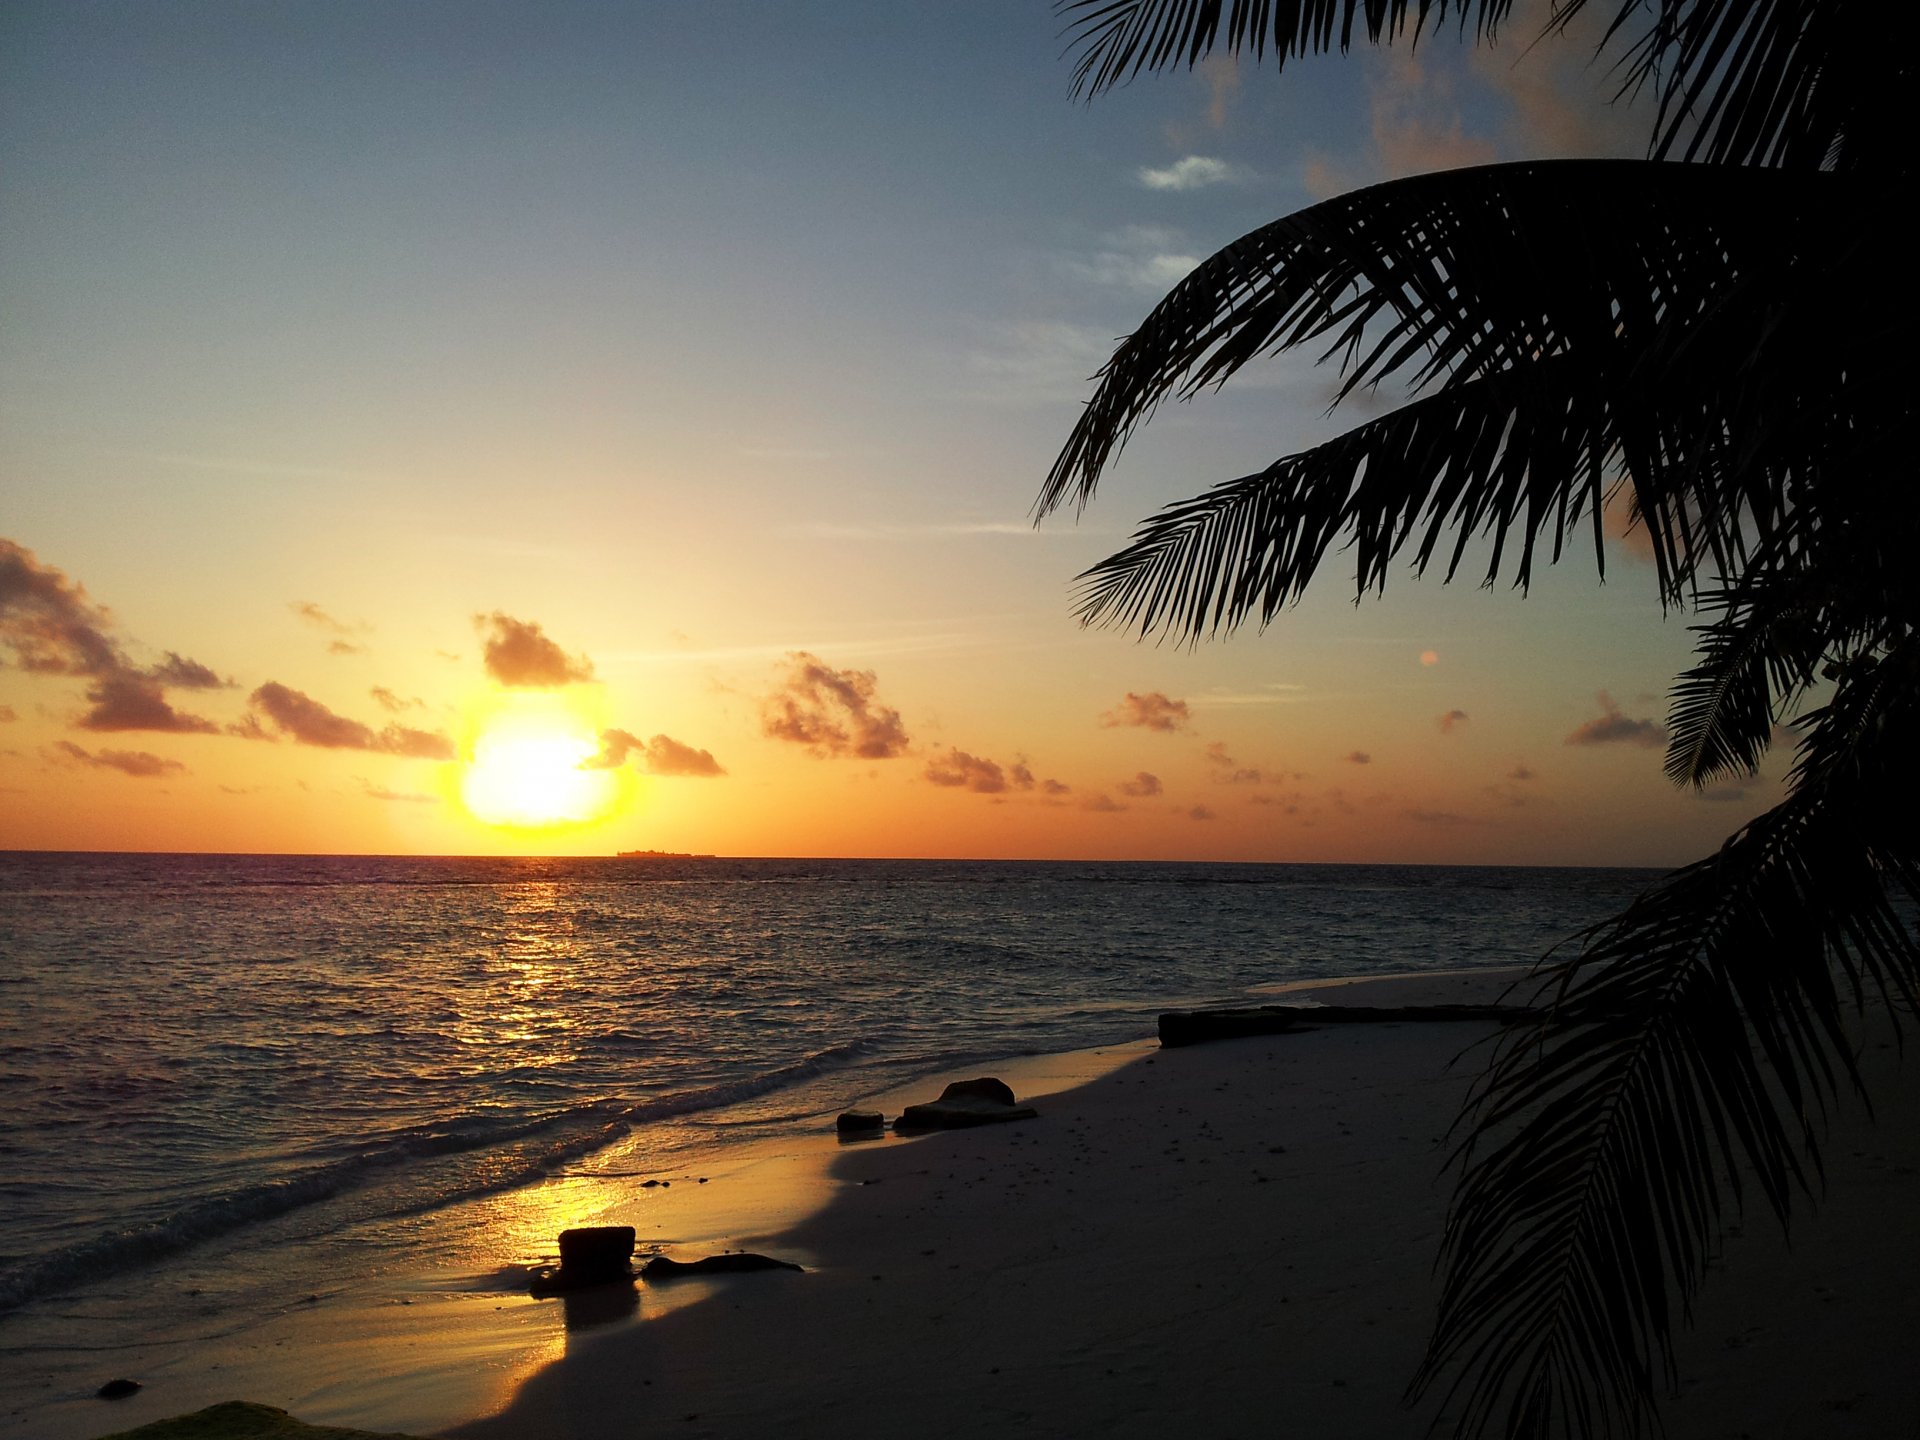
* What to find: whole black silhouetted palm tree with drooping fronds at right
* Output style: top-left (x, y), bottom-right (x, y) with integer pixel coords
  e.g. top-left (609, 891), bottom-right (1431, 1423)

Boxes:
top-left (1037, 0), bottom-right (1920, 1436)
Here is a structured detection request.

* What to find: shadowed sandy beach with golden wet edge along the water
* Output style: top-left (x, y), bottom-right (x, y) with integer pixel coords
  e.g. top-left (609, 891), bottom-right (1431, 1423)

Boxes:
top-left (90, 975), bottom-right (1920, 1440)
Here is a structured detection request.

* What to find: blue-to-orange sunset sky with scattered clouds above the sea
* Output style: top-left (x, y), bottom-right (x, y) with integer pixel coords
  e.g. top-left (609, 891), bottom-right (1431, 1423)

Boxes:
top-left (0, 0), bottom-right (1788, 864)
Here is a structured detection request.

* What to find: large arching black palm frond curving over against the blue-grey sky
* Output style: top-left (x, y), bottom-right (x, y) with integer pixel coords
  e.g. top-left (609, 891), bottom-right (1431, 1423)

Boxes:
top-left (1035, 161), bottom-right (1857, 611)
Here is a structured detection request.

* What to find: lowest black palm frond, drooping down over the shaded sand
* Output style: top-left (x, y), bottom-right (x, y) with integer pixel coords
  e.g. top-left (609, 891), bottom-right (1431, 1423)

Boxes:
top-left (1415, 641), bottom-right (1920, 1436)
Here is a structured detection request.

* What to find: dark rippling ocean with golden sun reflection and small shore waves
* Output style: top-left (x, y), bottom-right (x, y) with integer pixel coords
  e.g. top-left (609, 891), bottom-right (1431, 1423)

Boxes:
top-left (0, 852), bottom-right (1657, 1434)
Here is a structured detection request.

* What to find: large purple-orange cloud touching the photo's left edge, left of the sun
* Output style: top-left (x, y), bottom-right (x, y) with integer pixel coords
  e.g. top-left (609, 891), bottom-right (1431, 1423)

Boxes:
top-left (0, 540), bottom-right (225, 733)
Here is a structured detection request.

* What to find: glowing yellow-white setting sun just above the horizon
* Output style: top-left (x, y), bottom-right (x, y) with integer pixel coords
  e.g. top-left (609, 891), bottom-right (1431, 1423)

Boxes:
top-left (461, 693), bottom-right (624, 829)
